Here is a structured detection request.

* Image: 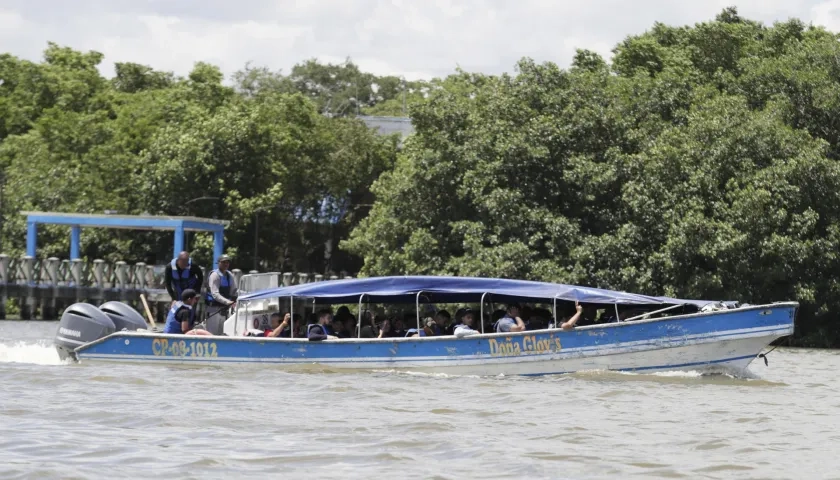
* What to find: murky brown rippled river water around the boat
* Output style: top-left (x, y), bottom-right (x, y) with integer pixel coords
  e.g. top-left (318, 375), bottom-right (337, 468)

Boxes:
top-left (0, 321), bottom-right (840, 479)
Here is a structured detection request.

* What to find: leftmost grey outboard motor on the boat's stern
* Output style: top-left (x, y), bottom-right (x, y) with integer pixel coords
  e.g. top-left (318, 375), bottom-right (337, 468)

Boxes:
top-left (55, 303), bottom-right (117, 360)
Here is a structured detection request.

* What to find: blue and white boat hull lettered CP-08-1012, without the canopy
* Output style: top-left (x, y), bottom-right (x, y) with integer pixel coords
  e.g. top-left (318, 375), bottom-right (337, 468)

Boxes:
top-left (70, 303), bottom-right (798, 375)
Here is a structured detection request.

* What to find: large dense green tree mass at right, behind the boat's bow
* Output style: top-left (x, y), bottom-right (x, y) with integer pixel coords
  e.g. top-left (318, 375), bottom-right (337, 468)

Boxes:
top-left (342, 8), bottom-right (840, 345)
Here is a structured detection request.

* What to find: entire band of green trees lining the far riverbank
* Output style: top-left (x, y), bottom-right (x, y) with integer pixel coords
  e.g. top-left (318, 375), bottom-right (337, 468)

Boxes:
top-left (0, 8), bottom-right (840, 348)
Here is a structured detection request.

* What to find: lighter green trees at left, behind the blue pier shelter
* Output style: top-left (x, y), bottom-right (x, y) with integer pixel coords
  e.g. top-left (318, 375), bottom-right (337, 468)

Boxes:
top-left (0, 44), bottom-right (396, 272)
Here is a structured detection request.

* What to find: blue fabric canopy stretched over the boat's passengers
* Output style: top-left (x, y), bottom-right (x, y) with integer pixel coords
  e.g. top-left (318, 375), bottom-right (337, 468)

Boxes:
top-left (239, 276), bottom-right (715, 307)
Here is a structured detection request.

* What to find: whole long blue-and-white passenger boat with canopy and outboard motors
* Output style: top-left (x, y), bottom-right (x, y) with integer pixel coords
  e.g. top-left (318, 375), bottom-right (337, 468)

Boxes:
top-left (56, 276), bottom-right (798, 375)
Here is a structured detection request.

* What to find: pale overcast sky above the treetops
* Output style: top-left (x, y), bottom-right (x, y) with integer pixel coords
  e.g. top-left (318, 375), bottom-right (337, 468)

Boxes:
top-left (0, 0), bottom-right (840, 79)
